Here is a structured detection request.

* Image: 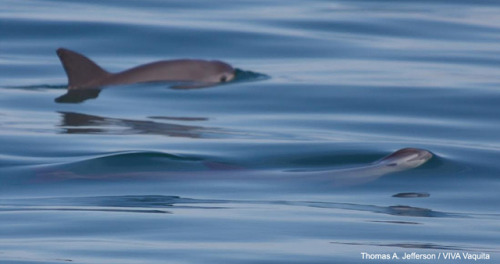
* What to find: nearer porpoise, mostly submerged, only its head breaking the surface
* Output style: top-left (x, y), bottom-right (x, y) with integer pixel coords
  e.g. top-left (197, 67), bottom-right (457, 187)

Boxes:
top-left (38, 148), bottom-right (433, 187)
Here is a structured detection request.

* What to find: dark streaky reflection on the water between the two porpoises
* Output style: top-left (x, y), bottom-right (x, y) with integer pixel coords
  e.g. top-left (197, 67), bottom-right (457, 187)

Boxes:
top-left (59, 112), bottom-right (220, 138)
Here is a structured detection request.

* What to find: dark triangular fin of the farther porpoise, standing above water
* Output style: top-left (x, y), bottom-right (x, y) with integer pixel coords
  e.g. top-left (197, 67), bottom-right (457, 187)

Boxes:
top-left (57, 48), bottom-right (110, 89)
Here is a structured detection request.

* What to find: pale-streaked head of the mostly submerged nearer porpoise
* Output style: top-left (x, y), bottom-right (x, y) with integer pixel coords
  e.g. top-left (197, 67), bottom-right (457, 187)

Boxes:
top-left (377, 148), bottom-right (433, 170)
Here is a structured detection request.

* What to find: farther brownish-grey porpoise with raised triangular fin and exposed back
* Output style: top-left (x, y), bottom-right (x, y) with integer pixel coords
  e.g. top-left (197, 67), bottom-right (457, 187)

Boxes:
top-left (57, 48), bottom-right (235, 89)
